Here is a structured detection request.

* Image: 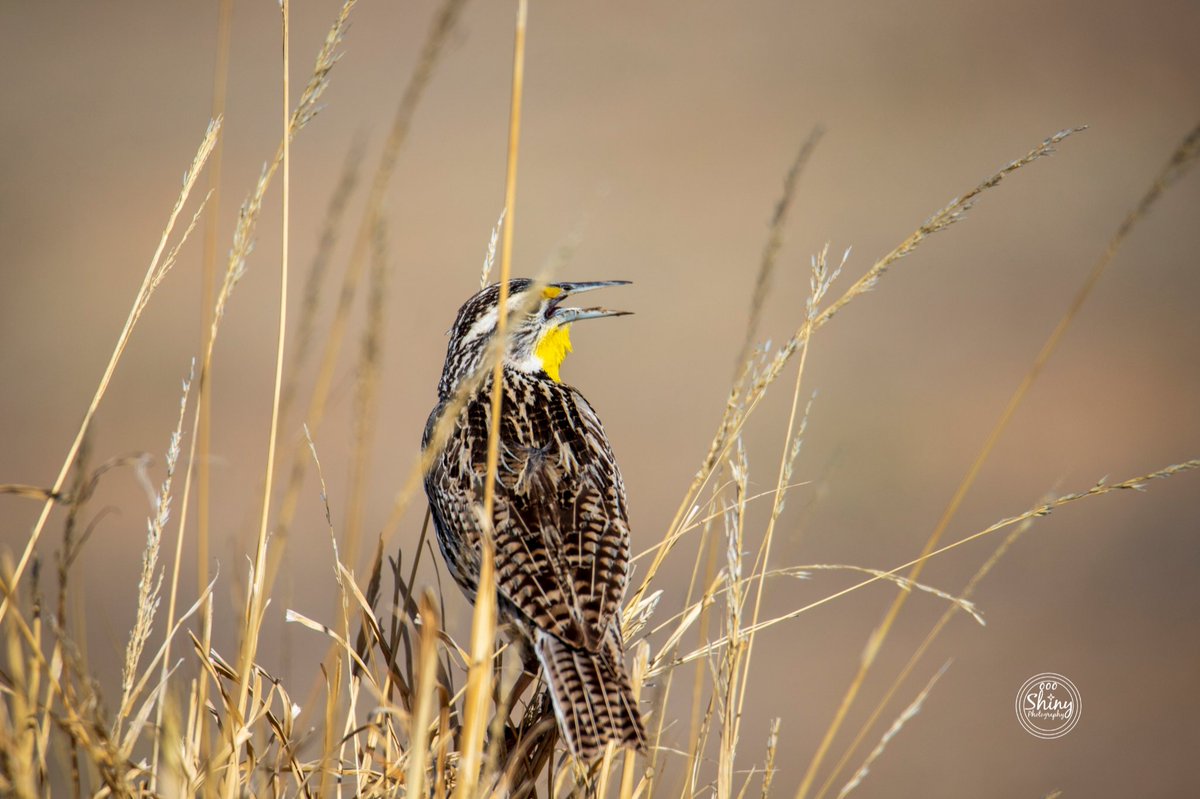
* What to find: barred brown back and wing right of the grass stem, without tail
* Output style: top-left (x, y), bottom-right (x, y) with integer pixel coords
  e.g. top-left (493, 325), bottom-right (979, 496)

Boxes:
top-left (496, 376), bottom-right (629, 650)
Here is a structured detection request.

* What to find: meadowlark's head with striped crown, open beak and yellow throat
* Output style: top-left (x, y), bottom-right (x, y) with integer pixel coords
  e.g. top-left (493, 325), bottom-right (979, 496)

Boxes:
top-left (438, 278), bottom-right (629, 397)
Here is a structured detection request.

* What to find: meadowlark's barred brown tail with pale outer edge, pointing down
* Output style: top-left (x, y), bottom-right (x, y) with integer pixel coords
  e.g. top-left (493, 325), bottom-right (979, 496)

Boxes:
top-left (534, 631), bottom-right (646, 763)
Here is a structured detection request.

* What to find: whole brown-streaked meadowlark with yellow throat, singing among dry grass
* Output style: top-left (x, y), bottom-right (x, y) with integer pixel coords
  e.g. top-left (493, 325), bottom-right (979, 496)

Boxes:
top-left (422, 280), bottom-right (646, 762)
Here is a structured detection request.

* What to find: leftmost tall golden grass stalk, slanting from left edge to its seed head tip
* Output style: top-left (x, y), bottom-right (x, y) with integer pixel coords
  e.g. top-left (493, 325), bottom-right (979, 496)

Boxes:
top-left (0, 119), bottom-right (221, 620)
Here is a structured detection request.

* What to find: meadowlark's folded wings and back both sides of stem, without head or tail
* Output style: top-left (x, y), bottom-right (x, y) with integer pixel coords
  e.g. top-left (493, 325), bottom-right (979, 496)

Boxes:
top-left (426, 373), bottom-right (629, 651)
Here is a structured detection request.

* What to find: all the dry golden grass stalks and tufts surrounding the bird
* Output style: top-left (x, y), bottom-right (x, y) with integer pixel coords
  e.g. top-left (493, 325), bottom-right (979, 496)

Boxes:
top-left (0, 0), bottom-right (1200, 799)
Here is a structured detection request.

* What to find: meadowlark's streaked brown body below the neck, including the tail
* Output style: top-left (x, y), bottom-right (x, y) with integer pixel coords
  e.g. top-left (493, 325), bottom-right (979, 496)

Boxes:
top-left (425, 367), bottom-right (644, 756)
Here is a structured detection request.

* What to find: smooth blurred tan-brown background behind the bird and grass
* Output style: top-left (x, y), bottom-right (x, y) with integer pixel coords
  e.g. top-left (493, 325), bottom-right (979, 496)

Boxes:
top-left (0, 0), bottom-right (1200, 798)
